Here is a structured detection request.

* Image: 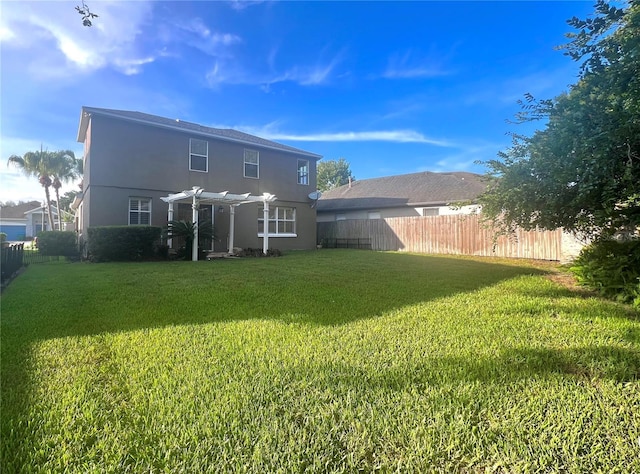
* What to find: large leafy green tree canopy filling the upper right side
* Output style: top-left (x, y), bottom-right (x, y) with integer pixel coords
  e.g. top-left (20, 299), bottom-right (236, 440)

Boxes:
top-left (480, 0), bottom-right (640, 238)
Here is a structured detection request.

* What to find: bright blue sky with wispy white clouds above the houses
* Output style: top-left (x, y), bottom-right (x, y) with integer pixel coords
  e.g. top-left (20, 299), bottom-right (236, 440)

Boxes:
top-left (0, 0), bottom-right (593, 201)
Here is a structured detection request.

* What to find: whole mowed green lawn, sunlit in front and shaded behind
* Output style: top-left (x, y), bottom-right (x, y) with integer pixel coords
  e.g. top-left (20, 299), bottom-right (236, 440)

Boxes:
top-left (0, 250), bottom-right (640, 473)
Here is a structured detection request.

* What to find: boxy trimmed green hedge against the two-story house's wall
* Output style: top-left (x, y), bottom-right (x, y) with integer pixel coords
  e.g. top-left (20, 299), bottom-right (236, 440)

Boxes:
top-left (87, 226), bottom-right (162, 262)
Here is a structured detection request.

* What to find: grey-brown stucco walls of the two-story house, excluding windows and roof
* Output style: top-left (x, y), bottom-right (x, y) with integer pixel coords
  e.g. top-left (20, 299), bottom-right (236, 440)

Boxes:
top-left (82, 114), bottom-right (316, 251)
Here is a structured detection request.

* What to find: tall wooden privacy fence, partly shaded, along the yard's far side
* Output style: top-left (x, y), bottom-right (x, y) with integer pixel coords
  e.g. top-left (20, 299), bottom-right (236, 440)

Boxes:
top-left (318, 214), bottom-right (562, 260)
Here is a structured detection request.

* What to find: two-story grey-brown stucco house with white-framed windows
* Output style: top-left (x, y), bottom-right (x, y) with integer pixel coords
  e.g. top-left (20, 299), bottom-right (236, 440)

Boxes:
top-left (76, 107), bottom-right (322, 251)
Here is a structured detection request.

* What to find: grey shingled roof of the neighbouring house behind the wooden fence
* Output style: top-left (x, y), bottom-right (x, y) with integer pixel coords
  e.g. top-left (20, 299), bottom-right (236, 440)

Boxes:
top-left (317, 171), bottom-right (486, 212)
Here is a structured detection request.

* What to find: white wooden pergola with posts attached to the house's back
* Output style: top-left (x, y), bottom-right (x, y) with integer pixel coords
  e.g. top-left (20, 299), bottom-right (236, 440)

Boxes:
top-left (160, 186), bottom-right (277, 262)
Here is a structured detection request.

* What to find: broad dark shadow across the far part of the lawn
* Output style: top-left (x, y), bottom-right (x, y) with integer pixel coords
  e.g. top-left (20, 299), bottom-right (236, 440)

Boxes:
top-left (2, 250), bottom-right (544, 340)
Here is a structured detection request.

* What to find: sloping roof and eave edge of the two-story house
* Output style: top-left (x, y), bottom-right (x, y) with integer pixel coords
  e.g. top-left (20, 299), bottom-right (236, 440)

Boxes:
top-left (78, 107), bottom-right (322, 160)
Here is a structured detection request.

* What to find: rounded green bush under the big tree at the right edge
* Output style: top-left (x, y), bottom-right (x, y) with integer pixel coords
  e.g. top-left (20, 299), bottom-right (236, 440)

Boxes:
top-left (571, 239), bottom-right (640, 308)
